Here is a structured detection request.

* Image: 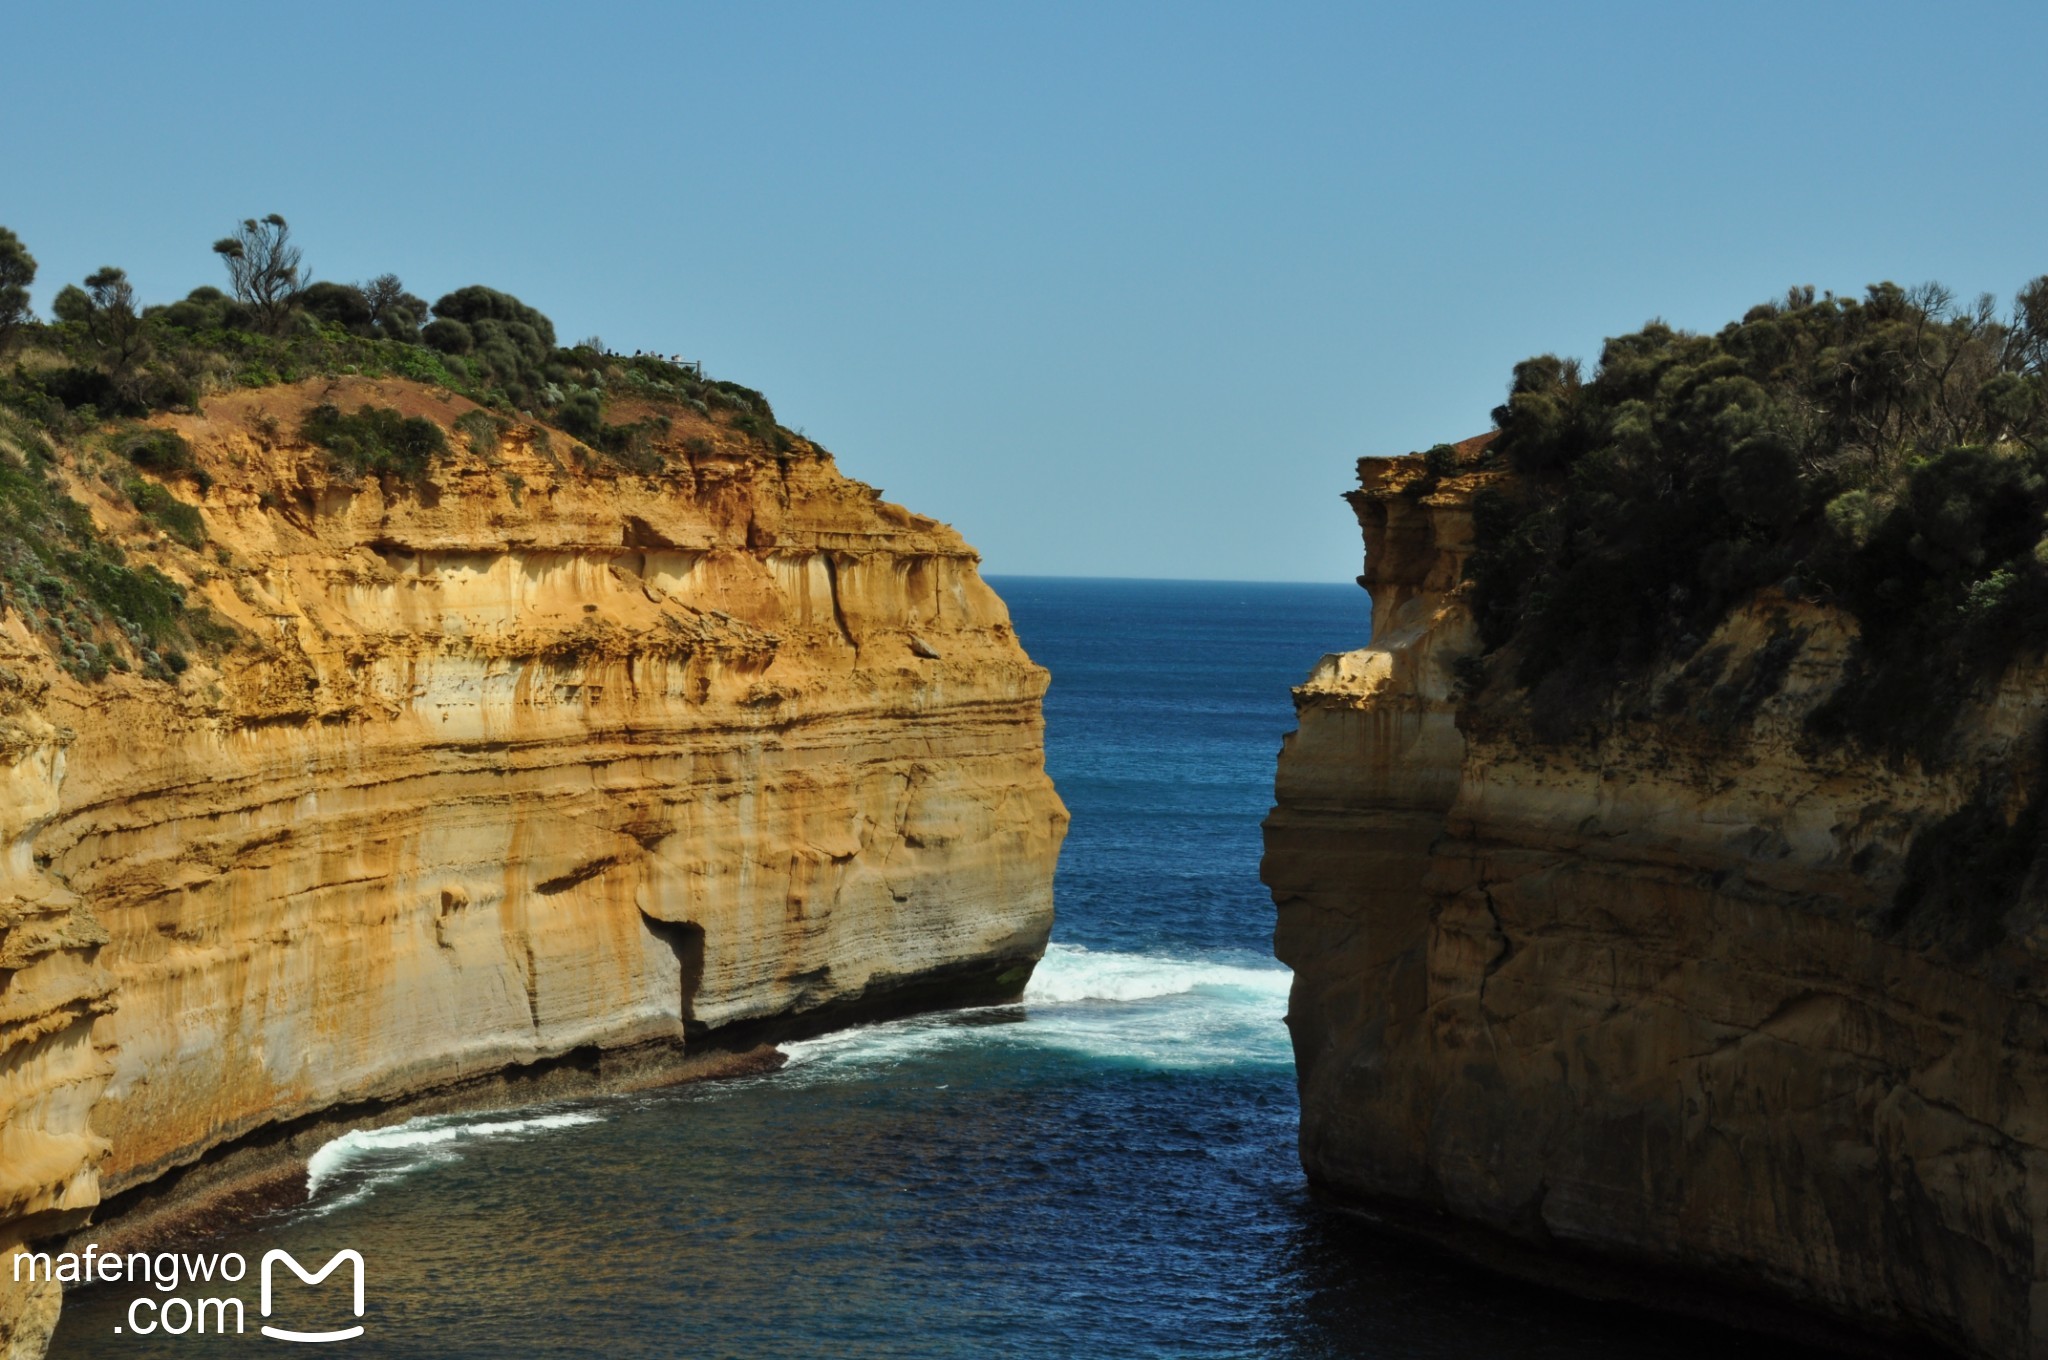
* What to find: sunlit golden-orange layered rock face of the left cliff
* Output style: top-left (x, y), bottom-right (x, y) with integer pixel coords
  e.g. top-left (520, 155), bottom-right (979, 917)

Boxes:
top-left (0, 379), bottom-right (1067, 1356)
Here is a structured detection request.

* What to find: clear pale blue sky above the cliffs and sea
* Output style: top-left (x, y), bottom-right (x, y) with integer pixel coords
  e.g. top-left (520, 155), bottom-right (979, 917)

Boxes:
top-left (0, 0), bottom-right (2048, 580)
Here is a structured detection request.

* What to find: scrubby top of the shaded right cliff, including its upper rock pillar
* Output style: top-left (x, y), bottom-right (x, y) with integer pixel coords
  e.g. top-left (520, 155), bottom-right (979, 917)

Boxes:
top-left (1331, 279), bottom-right (2048, 959)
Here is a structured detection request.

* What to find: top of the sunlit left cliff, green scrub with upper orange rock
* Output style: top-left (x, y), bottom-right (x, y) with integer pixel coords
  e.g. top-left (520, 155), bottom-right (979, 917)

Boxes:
top-left (0, 217), bottom-right (969, 696)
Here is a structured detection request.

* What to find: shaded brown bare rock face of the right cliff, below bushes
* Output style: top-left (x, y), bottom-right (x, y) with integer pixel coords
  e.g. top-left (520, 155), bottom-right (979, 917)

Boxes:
top-left (1264, 461), bottom-right (2048, 1356)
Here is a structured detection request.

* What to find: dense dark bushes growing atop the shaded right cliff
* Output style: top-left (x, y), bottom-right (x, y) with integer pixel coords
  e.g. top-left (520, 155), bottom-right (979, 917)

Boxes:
top-left (1470, 279), bottom-right (2048, 758)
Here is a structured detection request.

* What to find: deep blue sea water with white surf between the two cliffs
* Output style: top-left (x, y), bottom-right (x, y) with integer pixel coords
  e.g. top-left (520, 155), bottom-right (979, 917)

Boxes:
top-left (53, 578), bottom-right (1810, 1360)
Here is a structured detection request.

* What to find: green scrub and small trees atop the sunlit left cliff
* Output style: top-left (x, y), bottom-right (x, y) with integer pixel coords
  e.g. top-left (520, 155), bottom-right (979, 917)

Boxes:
top-left (0, 213), bottom-right (815, 680)
